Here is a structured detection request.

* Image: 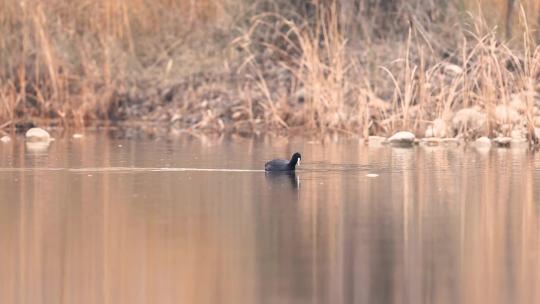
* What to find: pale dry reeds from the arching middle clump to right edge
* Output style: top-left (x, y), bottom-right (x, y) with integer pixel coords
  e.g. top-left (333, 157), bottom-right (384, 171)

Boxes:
top-left (235, 1), bottom-right (540, 141)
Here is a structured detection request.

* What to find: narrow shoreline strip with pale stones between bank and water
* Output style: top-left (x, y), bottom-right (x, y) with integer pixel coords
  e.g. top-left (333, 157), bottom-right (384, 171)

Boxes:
top-left (0, 122), bottom-right (539, 150)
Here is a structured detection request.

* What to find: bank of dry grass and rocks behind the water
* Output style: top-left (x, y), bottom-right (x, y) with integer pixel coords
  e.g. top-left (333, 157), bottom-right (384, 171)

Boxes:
top-left (0, 0), bottom-right (540, 141)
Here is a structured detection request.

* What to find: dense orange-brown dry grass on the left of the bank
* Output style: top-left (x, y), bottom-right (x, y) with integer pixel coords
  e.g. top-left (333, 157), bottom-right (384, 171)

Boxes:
top-left (0, 0), bottom-right (236, 126)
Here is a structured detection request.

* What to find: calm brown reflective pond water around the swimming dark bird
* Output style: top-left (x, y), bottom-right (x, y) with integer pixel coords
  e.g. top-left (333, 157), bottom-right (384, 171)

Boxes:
top-left (0, 134), bottom-right (540, 304)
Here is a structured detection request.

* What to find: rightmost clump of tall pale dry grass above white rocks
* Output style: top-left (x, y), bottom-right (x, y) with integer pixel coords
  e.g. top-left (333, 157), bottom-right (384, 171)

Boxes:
top-left (376, 3), bottom-right (540, 140)
